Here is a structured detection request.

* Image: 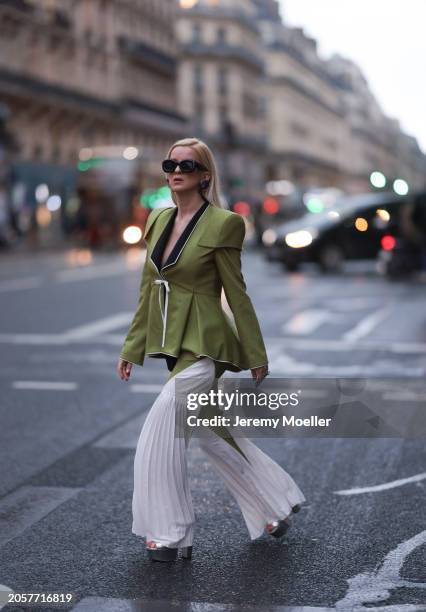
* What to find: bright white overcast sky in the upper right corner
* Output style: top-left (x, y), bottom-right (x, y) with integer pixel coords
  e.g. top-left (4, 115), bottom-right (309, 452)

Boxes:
top-left (279, 0), bottom-right (426, 153)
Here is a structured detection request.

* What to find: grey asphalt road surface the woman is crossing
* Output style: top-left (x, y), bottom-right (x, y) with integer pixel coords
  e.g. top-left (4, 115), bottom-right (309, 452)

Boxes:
top-left (0, 249), bottom-right (426, 612)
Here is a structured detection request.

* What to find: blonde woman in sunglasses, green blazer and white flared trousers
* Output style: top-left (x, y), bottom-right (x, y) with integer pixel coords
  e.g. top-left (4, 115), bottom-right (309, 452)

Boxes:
top-left (117, 138), bottom-right (305, 561)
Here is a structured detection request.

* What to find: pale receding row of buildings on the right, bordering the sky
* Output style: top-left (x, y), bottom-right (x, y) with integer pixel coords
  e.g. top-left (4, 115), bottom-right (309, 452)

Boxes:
top-left (258, 8), bottom-right (426, 193)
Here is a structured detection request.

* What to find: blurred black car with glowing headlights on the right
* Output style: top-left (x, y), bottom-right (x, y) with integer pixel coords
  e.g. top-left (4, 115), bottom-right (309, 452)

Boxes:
top-left (262, 192), bottom-right (410, 272)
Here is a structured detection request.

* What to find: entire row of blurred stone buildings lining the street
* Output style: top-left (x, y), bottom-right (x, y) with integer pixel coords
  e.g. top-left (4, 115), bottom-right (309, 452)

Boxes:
top-left (0, 0), bottom-right (425, 249)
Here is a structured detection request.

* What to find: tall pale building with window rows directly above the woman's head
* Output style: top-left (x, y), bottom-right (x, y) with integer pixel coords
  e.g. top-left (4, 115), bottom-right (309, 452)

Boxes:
top-left (176, 0), bottom-right (267, 199)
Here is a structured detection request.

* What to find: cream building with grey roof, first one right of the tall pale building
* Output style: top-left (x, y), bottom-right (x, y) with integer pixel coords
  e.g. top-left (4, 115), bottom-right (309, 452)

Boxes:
top-left (262, 20), bottom-right (347, 186)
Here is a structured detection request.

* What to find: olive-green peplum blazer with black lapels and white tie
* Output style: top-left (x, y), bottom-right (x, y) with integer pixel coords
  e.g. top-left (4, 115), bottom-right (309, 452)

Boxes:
top-left (120, 203), bottom-right (268, 373)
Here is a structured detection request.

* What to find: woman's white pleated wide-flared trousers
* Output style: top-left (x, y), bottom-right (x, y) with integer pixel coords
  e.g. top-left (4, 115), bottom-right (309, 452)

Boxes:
top-left (132, 357), bottom-right (305, 547)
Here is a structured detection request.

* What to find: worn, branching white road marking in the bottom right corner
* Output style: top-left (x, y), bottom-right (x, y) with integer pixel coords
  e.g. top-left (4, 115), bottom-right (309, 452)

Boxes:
top-left (335, 530), bottom-right (426, 612)
